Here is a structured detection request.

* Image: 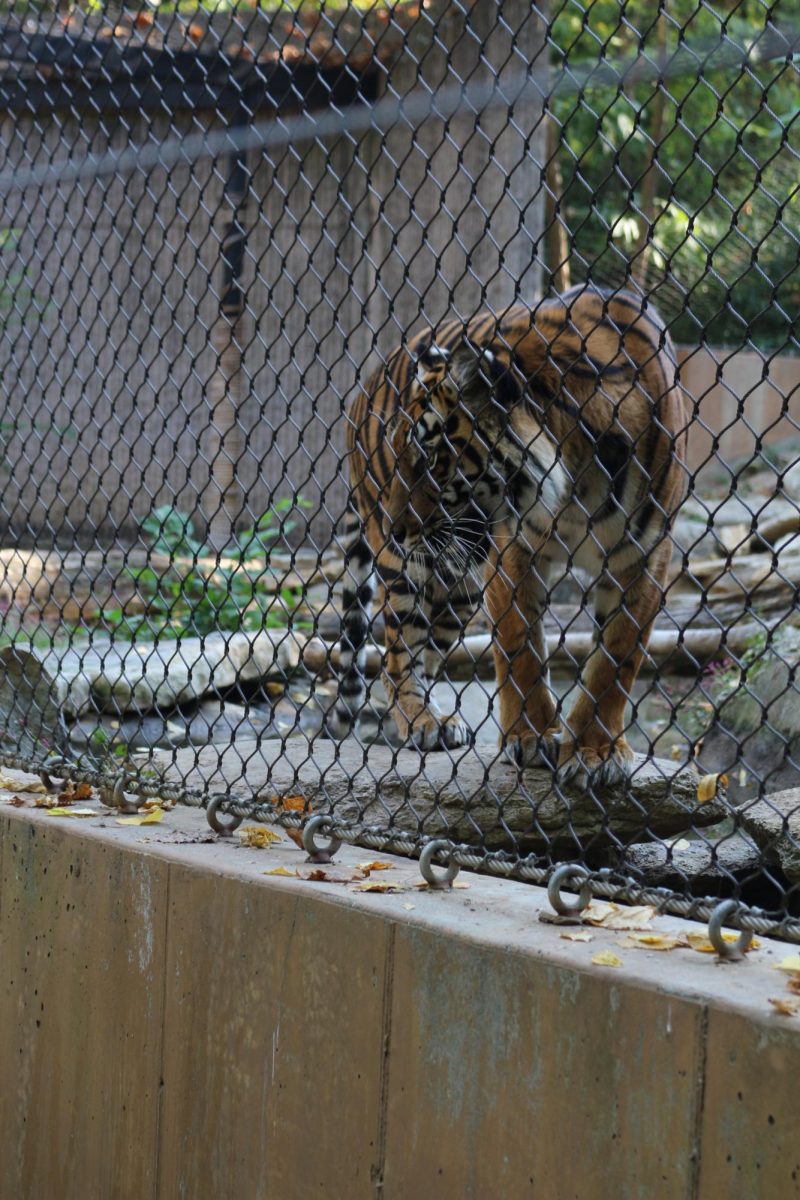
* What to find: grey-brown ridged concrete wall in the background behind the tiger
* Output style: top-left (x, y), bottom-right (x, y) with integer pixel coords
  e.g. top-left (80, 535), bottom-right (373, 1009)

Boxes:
top-left (0, 0), bottom-right (545, 545)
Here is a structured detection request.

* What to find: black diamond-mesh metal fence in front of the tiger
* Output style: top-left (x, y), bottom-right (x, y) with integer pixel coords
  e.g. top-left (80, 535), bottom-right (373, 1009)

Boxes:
top-left (0, 0), bottom-right (800, 941)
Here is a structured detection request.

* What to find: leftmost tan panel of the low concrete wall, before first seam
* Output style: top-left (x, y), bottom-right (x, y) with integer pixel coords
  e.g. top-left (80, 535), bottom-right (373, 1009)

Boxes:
top-left (0, 808), bottom-right (169, 1200)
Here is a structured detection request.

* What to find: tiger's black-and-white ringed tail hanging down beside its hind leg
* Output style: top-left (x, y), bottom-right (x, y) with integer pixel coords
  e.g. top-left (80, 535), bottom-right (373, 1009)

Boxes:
top-left (327, 512), bottom-right (377, 738)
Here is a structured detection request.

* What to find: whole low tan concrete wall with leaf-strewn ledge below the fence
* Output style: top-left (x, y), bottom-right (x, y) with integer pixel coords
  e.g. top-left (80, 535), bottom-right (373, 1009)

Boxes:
top-left (0, 782), bottom-right (800, 1200)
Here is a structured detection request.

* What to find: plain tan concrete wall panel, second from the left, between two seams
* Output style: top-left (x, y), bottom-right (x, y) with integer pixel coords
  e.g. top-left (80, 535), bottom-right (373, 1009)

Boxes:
top-left (158, 864), bottom-right (390, 1200)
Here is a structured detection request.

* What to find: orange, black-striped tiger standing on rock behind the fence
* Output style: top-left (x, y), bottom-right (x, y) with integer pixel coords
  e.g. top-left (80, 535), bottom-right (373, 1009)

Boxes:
top-left (333, 284), bottom-right (690, 788)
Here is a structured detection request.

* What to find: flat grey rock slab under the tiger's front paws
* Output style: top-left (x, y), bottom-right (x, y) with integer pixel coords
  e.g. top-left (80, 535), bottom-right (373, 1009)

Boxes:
top-left (163, 738), bottom-right (730, 854)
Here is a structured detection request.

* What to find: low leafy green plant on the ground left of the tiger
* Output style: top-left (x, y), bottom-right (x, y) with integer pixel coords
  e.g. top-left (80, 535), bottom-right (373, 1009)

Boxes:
top-left (103, 498), bottom-right (309, 640)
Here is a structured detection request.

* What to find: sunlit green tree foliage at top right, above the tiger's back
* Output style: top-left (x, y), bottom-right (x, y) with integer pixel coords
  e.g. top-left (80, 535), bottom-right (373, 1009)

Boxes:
top-left (551, 0), bottom-right (800, 350)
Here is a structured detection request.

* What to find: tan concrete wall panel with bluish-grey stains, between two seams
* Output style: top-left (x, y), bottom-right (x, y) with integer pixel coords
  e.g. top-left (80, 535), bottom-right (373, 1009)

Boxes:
top-left (385, 926), bottom-right (703, 1200)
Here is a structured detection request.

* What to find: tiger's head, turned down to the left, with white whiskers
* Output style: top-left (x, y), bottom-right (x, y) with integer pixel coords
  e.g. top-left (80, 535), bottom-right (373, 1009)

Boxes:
top-left (381, 338), bottom-right (565, 578)
